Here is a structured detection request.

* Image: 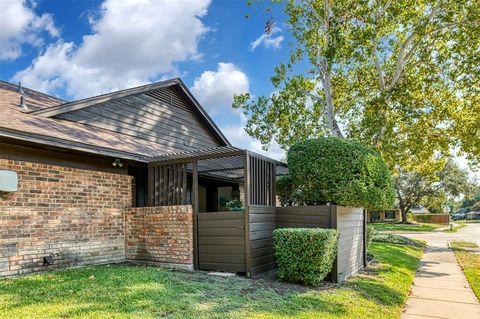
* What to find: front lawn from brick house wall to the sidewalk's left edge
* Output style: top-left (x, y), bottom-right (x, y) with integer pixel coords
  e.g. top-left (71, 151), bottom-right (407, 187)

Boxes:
top-left (0, 243), bottom-right (422, 319)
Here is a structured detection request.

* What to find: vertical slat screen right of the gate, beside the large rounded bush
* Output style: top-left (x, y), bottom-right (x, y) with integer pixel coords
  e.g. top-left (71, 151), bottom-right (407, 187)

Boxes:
top-left (248, 155), bottom-right (275, 206)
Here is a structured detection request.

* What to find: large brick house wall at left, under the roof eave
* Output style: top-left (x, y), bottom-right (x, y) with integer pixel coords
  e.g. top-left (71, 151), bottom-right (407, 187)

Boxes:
top-left (0, 159), bottom-right (132, 277)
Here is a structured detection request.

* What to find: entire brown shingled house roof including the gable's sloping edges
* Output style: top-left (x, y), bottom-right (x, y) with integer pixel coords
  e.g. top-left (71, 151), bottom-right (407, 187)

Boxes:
top-left (0, 79), bottom-right (230, 162)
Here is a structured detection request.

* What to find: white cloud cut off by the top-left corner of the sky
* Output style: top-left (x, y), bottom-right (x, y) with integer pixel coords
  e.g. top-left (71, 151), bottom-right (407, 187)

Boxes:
top-left (0, 0), bottom-right (60, 61)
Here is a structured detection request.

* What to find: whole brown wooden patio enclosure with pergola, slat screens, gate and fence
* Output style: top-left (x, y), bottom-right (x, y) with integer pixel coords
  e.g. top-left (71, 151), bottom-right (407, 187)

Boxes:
top-left (148, 146), bottom-right (366, 281)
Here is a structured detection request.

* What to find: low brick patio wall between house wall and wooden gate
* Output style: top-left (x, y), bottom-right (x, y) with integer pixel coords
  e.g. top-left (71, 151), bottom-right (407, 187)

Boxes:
top-left (126, 205), bottom-right (193, 268)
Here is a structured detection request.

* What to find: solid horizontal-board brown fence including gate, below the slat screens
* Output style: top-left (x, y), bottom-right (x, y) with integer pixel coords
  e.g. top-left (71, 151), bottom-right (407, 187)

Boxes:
top-left (198, 205), bottom-right (366, 282)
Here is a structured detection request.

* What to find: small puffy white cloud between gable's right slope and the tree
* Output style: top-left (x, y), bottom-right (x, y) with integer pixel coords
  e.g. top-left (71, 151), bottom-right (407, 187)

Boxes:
top-left (191, 62), bottom-right (249, 112)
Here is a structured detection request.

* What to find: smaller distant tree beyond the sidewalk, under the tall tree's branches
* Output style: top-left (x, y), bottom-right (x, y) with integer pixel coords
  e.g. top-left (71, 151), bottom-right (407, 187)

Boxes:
top-left (394, 160), bottom-right (471, 222)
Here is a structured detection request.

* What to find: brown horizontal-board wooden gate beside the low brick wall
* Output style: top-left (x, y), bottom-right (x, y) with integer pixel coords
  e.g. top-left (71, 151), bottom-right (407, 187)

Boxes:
top-left (198, 212), bottom-right (246, 272)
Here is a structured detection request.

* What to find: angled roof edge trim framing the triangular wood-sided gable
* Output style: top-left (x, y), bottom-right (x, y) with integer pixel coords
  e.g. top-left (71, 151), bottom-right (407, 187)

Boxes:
top-left (31, 78), bottom-right (231, 145)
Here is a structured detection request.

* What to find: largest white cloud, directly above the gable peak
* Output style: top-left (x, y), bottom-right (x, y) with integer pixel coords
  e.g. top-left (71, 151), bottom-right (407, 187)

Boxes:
top-left (14, 0), bottom-right (210, 98)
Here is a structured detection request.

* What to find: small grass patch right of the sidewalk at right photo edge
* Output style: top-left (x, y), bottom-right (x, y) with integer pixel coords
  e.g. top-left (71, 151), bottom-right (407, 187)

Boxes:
top-left (450, 241), bottom-right (480, 299)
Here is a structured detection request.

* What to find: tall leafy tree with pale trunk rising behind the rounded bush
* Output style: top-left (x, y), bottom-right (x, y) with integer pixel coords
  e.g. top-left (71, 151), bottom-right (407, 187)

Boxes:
top-left (233, 0), bottom-right (480, 171)
